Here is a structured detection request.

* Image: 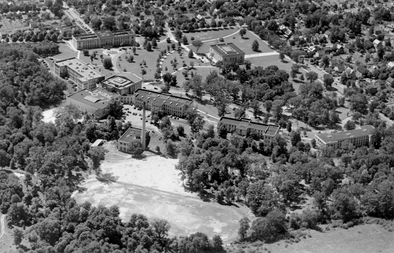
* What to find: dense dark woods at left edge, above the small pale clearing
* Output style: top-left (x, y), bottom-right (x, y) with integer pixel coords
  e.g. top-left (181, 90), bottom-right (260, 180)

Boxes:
top-left (0, 45), bottom-right (66, 108)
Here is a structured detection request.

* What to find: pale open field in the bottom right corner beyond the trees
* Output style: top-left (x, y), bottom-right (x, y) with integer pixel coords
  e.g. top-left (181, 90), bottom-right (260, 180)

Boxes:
top-left (264, 224), bottom-right (394, 253)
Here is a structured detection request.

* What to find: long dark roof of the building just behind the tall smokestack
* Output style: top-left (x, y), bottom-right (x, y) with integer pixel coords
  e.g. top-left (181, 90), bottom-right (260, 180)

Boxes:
top-left (135, 89), bottom-right (193, 106)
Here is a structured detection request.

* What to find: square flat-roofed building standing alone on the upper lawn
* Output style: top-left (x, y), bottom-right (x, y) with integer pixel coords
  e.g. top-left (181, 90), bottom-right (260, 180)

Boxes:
top-left (209, 43), bottom-right (245, 64)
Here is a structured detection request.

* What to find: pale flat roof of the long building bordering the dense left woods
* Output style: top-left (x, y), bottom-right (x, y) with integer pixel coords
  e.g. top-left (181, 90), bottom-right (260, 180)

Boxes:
top-left (55, 57), bottom-right (104, 81)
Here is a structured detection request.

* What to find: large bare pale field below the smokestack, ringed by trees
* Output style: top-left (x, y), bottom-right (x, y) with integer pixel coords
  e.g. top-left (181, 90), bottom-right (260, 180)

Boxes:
top-left (73, 143), bottom-right (252, 243)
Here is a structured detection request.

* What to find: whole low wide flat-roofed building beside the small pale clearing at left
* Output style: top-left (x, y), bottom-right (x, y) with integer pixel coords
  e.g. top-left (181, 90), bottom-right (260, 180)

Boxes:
top-left (66, 88), bottom-right (120, 119)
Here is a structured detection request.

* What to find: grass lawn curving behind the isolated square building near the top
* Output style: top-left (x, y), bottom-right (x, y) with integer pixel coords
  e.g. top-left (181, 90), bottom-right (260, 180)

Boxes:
top-left (189, 28), bottom-right (279, 55)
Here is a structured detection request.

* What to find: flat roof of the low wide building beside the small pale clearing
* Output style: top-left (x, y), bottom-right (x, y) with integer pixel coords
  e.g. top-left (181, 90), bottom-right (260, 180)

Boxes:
top-left (68, 88), bottom-right (120, 109)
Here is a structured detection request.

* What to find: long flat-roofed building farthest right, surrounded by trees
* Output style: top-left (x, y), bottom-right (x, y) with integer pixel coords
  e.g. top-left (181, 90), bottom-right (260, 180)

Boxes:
top-left (315, 125), bottom-right (375, 149)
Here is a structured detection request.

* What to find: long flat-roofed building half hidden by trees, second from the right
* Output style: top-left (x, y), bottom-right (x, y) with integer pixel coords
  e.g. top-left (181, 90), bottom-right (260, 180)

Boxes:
top-left (219, 117), bottom-right (279, 141)
